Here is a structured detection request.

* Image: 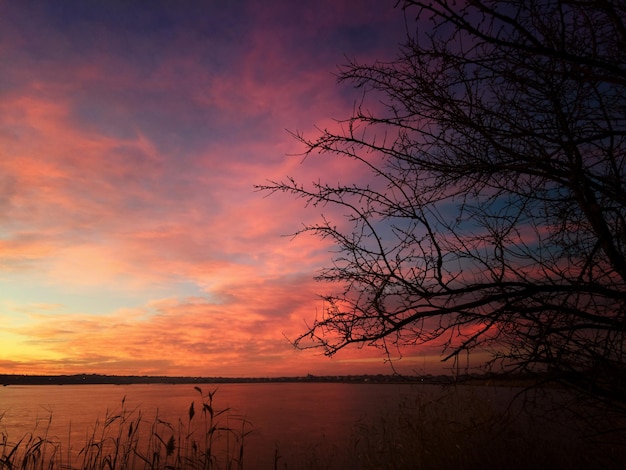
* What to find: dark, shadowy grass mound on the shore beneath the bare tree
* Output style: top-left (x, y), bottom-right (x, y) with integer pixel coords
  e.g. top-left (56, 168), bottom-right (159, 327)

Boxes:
top-left (276, 386), bottom-right (626, 470)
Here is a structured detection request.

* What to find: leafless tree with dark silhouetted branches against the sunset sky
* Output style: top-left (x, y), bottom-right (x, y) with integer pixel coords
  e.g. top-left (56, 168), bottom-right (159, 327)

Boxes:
top-left (259, 0), bottom-right (626, 402)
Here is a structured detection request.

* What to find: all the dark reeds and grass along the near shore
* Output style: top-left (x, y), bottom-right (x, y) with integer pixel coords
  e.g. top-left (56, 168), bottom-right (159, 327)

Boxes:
top-left (0, 386), bottom-right (626, 470)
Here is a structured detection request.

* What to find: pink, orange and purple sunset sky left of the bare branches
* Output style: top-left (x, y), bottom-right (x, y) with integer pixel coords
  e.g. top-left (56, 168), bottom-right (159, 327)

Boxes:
top-left (0, 0), bottom-right (444, 377)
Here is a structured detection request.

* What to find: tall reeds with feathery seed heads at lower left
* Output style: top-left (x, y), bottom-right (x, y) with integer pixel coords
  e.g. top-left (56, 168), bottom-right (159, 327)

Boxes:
top-left (0, 387), bottom-right (250, 470)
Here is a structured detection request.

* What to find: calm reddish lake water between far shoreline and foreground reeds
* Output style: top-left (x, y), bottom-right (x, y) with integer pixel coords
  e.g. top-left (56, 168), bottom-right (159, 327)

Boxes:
top-left (0, 383), bottom-right (424, 467)
